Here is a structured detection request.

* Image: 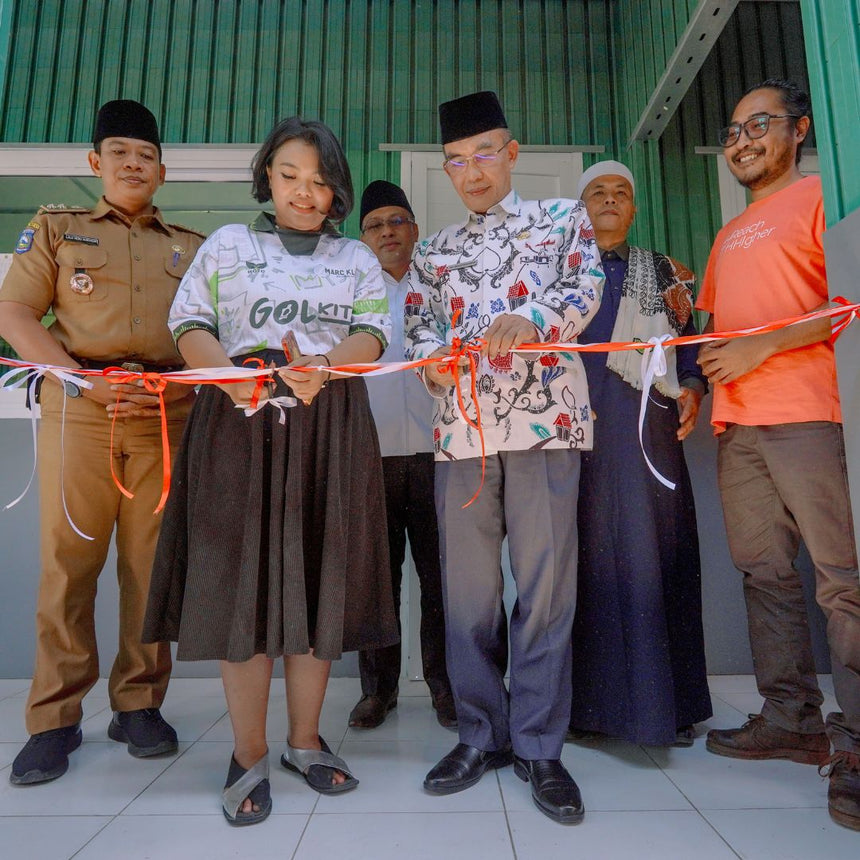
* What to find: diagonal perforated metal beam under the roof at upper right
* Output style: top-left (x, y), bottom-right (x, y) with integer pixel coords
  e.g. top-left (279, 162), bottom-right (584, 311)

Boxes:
top-left (627, 0), bottom-right (738, 148)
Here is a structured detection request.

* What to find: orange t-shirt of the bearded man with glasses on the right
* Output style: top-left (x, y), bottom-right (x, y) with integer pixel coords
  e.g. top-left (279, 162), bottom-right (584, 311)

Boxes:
top-left (696, 176), bottom-right (842, 433)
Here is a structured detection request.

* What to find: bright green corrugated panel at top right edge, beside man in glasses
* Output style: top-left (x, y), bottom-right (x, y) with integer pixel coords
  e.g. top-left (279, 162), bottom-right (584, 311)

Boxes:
top-left (801, 0), bottom-right (860, 226)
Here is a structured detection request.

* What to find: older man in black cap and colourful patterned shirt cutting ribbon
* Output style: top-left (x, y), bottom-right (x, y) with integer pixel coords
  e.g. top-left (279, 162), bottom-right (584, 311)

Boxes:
top-left (406, 92), bottom-right (603, 824)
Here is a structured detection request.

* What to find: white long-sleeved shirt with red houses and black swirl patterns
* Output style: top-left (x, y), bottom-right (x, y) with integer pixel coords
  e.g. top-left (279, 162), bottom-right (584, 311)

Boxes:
top-left (405, 191), bottom-right (604, 460)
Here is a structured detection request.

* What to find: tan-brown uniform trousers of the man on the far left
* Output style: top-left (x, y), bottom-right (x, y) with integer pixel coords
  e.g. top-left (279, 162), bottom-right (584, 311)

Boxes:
top-left (26, 381), bottom-right (193, 734)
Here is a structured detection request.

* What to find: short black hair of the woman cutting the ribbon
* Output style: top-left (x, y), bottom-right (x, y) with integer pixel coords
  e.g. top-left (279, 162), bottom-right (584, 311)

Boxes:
top-left (251, 116), bottom-right (355, 224)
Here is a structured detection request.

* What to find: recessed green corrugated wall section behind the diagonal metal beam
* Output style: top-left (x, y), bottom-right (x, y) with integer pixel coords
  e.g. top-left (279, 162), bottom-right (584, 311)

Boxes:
top-left (613, 0), bottom-right (807, 277)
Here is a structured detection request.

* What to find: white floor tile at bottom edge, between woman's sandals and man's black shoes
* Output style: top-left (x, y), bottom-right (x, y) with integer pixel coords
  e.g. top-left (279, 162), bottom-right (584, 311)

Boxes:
top-left (295, 812), bottom-right (514, 860)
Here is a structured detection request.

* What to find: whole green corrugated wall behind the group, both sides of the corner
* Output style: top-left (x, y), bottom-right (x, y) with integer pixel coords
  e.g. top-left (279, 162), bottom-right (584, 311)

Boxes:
top-left (0, 0), bottom-right (832, 274)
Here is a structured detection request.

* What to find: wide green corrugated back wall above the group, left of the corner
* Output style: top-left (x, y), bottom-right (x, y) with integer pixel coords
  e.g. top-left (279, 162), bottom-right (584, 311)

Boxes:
top-left (0, 0), bottom-right (613, 233)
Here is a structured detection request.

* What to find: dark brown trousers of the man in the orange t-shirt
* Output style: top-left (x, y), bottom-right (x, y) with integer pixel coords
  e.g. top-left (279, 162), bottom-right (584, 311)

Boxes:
top-left (717, 421), bottom-right (860, 753)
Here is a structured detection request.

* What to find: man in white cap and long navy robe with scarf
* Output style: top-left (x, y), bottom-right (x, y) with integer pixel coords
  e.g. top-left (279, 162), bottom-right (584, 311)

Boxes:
top-left (570, 161), bottom-right (711, 746)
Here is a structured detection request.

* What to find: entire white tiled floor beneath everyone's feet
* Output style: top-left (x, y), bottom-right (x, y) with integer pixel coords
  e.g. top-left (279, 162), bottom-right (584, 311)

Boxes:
top-left (0, 675), bottom-right (860, 860)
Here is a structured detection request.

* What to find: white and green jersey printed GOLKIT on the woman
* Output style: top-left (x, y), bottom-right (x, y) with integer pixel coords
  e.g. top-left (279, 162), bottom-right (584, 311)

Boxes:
top-left (168, 216), bottom-right (391, 358)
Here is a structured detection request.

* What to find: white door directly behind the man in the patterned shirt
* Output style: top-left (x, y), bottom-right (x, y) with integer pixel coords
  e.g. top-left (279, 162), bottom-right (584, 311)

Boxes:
top-left (400, 147), bottom-right (582, 681)
